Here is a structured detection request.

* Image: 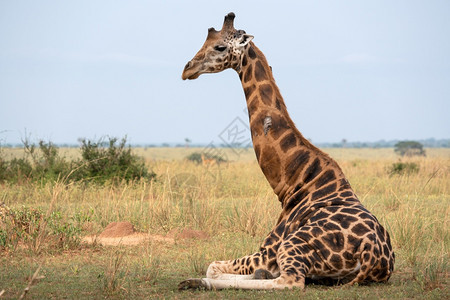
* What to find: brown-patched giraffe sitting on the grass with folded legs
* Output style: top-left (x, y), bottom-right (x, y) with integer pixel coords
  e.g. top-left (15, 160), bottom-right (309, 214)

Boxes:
top-left (178, 13), bottom-right (395, 289)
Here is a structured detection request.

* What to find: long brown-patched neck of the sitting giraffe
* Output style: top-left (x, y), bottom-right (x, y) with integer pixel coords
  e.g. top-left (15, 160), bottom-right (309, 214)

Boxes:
top-left (239, 42), bottom-right (346, 208)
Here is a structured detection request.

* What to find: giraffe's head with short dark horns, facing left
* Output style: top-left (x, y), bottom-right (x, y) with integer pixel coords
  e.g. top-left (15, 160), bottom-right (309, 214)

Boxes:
top-left (181, 13), bottom-right (253, 80)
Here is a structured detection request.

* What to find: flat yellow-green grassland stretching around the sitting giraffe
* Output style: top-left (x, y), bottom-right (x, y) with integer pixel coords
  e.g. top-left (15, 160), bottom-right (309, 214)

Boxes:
top-left (0, 148), bottom-right (450, 299)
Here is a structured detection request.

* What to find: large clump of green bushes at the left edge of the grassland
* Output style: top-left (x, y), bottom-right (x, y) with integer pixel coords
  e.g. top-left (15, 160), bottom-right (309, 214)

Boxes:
top-left (0, 138), bottom-right (156, 184)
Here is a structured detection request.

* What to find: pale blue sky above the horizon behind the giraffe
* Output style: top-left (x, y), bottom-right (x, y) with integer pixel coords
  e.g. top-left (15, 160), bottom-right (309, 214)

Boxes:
top-left (0, 0), bottom-right (450, 144)
